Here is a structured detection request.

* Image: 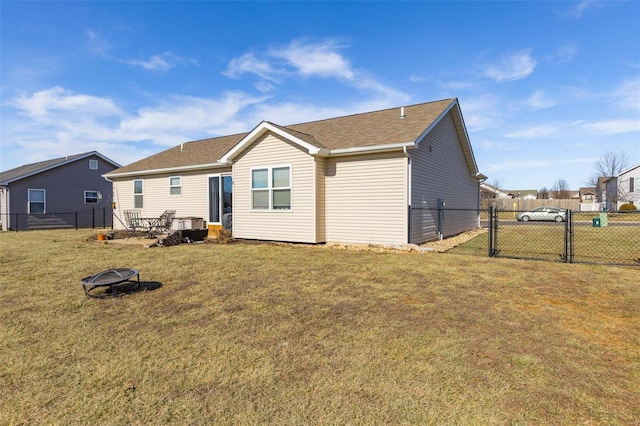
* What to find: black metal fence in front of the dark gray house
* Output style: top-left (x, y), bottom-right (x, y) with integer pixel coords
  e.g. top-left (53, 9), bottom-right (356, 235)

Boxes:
top-left (0, 207), bottom-right (113, 232)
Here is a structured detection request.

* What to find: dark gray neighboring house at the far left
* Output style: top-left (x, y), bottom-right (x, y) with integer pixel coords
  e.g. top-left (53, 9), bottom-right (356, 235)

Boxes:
top-left (0, 151), bottom-right (120, 231)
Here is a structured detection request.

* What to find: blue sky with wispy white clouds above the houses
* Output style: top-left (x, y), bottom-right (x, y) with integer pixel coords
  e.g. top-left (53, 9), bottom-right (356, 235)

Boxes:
top-left (0, 1), bottom-right (640, 189)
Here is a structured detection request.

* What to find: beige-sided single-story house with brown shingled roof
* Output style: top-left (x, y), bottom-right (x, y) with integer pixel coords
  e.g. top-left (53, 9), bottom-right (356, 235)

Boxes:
top-left (105, 99), bottom-right (485, 244)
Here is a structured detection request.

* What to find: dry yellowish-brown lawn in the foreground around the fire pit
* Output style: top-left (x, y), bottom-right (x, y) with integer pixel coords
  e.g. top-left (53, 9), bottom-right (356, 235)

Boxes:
top-left (0, 231), bottom-right (640, 425)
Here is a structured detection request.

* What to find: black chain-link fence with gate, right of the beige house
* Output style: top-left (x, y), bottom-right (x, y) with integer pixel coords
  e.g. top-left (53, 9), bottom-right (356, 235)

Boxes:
top-left (409, 207), bottom-right (640, 266)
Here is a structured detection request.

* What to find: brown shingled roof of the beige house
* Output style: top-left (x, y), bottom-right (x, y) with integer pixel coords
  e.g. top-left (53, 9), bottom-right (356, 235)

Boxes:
top-left (107, 99), bottom-right (455, 176)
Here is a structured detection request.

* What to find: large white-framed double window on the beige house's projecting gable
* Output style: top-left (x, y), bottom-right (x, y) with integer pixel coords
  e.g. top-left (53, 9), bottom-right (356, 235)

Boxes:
top-left (251, 166), bottom-right (291, 210)
